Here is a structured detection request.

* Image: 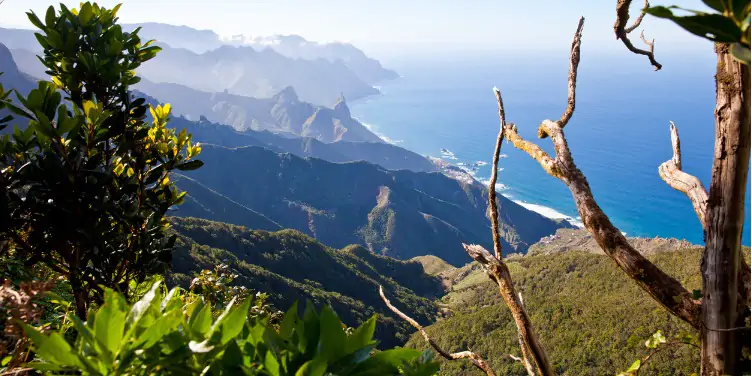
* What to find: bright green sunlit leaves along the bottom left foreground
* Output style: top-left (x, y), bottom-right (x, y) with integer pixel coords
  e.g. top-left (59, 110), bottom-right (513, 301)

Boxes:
top-left (25, 284), bottom-right (438, 376)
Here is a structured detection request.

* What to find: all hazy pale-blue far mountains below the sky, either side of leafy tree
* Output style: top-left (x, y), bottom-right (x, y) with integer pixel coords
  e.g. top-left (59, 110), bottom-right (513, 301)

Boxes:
top-left (0, 23), bottom-right (397, 105)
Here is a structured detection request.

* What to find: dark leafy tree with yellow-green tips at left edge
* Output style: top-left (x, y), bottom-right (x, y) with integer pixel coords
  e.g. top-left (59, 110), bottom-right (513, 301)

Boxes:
top-left (0, 2), bottom-right (202, 318)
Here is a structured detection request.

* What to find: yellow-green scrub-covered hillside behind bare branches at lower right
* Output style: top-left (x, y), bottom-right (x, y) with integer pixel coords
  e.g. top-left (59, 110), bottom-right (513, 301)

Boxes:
top-left (408, 235), bottom-right (702, 375)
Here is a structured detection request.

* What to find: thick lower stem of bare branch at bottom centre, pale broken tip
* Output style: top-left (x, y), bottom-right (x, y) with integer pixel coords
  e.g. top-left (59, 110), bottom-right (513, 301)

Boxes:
top-left (462, 244), bottom-right (554, 376)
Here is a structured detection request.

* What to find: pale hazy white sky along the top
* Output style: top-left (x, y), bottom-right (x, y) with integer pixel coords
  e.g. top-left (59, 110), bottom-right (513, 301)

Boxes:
top-left (0, 0), bottom-right (707, 54)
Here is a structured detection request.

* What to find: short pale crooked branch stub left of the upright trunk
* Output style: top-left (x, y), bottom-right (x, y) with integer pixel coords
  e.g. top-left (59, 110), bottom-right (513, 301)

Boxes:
top-left (658, 122), bottom-right (708, 228)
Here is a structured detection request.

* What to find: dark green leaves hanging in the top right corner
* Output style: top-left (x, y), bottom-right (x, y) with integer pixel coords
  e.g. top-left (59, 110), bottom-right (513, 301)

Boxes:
top-left (646, 0), bottom-right (750, 65)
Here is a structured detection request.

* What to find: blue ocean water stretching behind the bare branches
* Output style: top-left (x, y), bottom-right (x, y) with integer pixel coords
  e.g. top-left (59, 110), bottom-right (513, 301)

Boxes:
top-left (351, 51), bottom-right (750, 245)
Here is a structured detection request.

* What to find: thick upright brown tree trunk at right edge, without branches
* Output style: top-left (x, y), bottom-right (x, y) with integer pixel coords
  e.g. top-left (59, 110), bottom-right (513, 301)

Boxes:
top-left (700, 44), bottom-right (750, 376)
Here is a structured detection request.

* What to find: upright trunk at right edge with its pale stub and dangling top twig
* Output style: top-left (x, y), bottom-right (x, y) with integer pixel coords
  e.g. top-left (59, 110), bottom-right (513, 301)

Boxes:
top-left (614, 0), bottom-right (750, 375)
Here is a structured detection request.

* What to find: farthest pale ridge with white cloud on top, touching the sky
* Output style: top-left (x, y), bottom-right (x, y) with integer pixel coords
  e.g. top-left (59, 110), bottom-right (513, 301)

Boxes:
top-left (226, 35), bottom-right (399, 84)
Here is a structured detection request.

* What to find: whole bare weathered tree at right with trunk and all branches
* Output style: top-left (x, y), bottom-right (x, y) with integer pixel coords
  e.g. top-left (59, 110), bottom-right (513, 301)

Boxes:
top-left (384, 0), bottom-right (750, 375)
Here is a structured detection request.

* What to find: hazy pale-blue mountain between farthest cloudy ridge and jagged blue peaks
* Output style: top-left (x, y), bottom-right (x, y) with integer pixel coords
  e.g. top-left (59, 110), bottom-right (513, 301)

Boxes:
top-left (138, 43), bottom-right (379, 105)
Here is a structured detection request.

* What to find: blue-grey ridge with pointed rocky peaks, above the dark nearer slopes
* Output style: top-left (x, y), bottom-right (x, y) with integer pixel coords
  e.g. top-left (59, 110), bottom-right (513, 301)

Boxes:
top-left (135, 80), bottom-right (383, 142)
